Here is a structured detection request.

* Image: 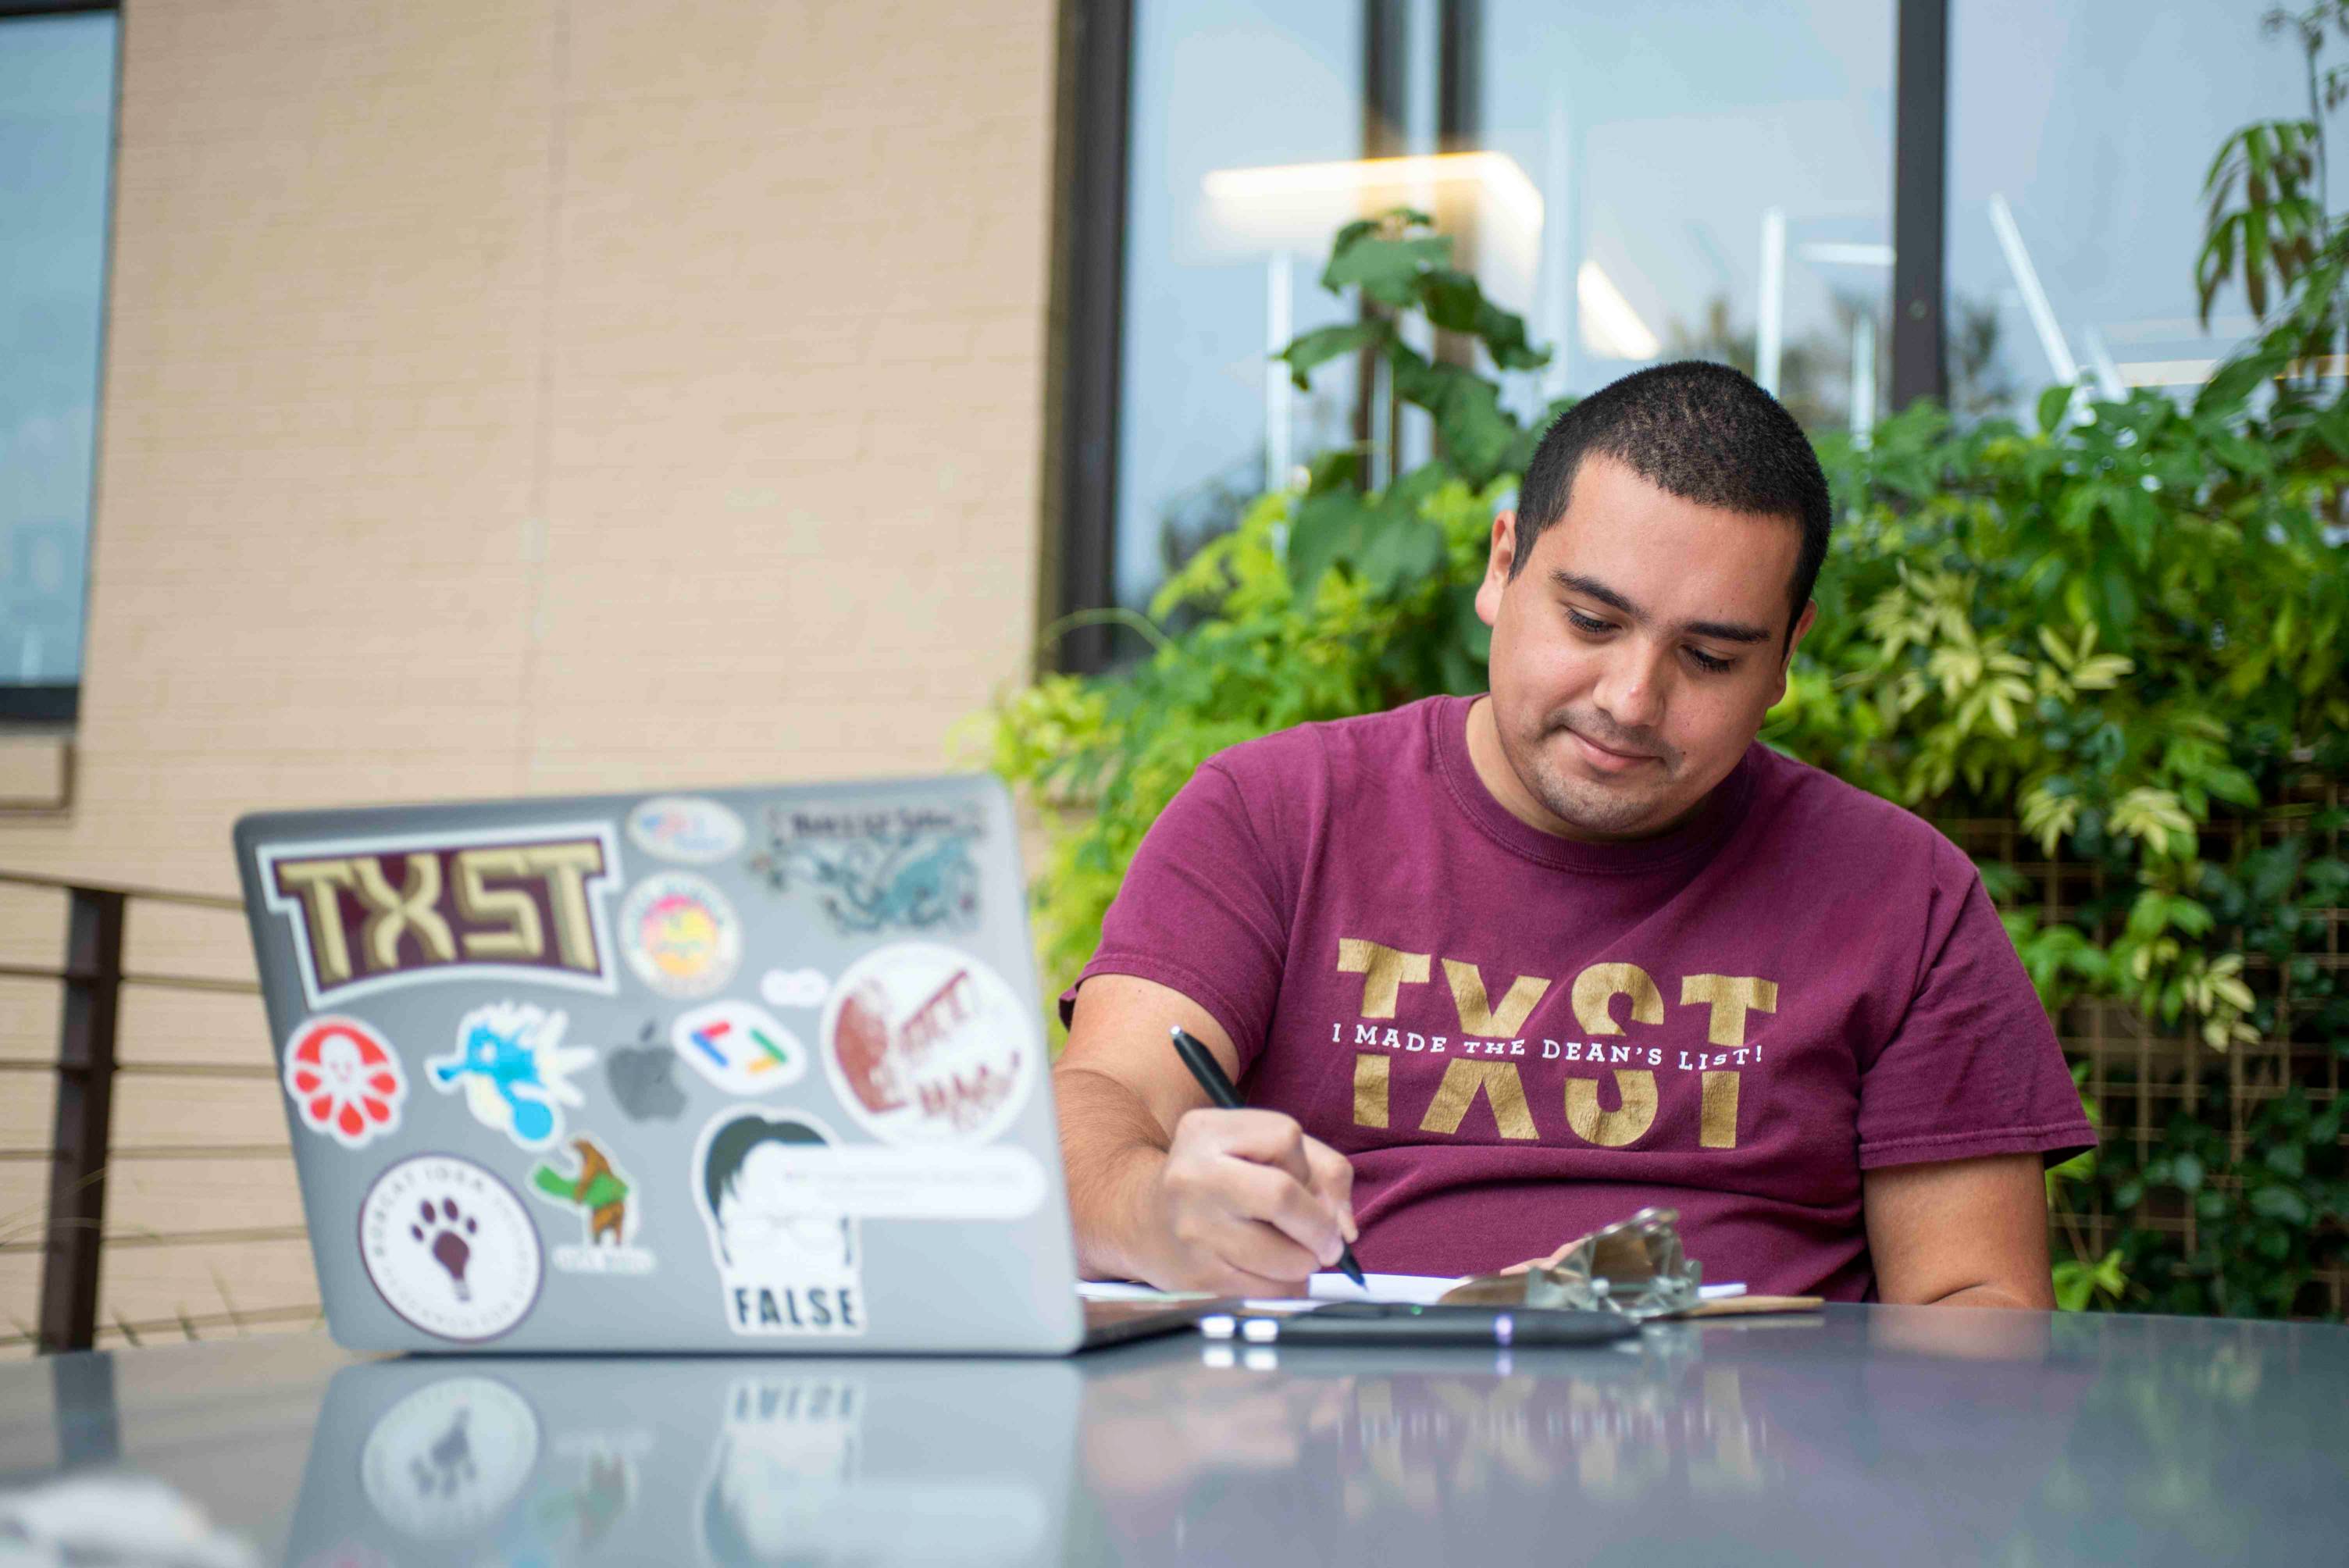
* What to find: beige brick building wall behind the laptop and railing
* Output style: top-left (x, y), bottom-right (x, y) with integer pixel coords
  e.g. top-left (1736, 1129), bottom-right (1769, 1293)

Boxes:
top-left (0, 0), bottom-right (1055, 1340)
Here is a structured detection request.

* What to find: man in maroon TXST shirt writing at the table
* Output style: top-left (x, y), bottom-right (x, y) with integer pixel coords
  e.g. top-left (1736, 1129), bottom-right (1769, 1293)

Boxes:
top-left (1055, 364), bottom-right (2093, 1307)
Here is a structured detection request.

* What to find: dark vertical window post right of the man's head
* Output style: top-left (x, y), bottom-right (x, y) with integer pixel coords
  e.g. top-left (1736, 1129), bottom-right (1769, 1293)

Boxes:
top-left (1893, 0), bottom-right (1950, 408)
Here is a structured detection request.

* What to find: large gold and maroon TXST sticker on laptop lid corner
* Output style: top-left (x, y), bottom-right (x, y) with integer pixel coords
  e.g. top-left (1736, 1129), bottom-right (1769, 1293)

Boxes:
top-left (258, 824), bottom-right (620, 1010)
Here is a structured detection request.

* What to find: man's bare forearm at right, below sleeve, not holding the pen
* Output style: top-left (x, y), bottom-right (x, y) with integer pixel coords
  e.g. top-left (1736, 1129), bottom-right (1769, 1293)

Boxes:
top-left (1860, 1155), bottom-right (2055, 1310)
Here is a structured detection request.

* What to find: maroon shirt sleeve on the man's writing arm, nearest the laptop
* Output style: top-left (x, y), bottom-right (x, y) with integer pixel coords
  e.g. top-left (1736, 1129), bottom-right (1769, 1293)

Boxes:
top-left (1060, 761), bottom-right (1294, 1073)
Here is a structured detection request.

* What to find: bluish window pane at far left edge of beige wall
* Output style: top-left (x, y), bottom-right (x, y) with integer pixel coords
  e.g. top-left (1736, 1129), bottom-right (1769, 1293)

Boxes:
top-left (0, 12), bottom-right (115, 686)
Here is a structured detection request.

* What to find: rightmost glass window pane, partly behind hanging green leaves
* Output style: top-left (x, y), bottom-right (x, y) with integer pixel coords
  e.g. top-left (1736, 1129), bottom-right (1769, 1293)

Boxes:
top-left (1948, 0), bottom-right (2309, 422)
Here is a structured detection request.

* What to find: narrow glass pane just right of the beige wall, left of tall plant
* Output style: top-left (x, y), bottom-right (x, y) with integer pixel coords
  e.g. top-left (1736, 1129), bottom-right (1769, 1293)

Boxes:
top-left (1116, 0), bottom-right (1363, 608)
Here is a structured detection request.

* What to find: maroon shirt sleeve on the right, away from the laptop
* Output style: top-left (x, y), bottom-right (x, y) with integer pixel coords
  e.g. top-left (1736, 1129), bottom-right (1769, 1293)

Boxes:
top-left (1858, 847), bottom-right (2095, 1171)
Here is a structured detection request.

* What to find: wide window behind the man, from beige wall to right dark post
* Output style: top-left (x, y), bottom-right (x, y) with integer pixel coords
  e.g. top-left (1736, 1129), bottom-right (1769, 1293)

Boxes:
top-left (1062, 0), bottom-right (1898, 638)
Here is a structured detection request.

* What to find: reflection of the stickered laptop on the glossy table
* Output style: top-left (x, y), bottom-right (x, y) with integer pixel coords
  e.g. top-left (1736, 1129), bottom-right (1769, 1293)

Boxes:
top-left (289, 1359), bottom-right (1078, 1566)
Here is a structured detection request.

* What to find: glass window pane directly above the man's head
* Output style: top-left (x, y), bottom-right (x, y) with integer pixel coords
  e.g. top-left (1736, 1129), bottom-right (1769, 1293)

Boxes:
top-left (1480, 0), bottom-right (1893, 441)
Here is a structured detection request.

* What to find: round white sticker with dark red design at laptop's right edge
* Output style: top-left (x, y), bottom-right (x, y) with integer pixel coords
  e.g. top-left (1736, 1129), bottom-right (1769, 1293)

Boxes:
top-left (822, 941), bottom-right (1043, 1143)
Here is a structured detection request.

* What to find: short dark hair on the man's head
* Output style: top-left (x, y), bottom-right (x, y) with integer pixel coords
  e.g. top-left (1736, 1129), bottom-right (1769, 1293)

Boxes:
top-left (1508, 359), bottom-right (1834, 636)
